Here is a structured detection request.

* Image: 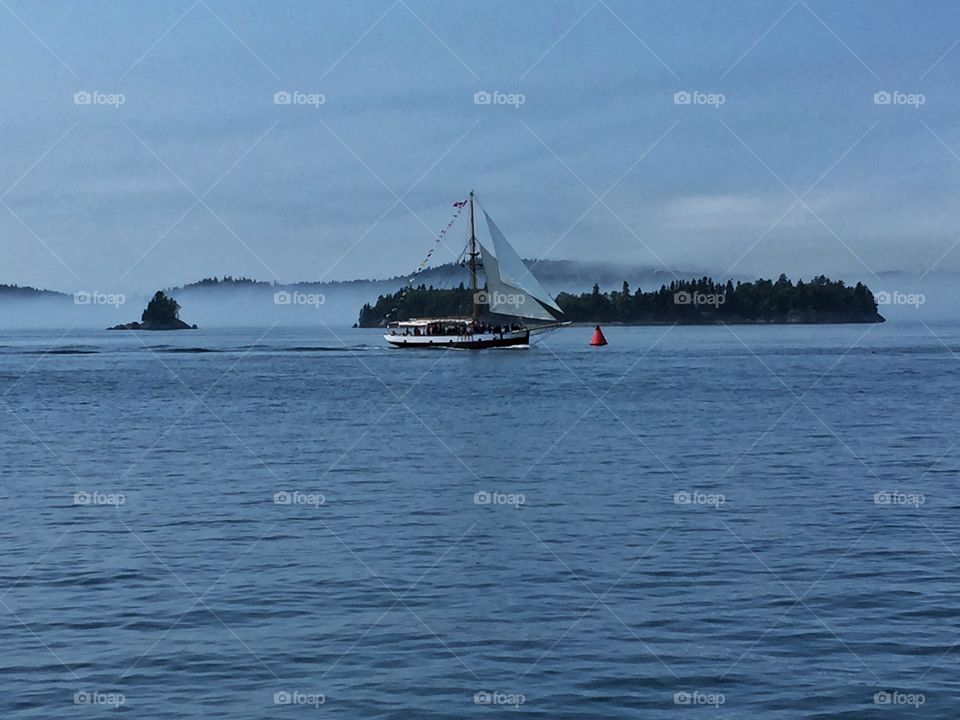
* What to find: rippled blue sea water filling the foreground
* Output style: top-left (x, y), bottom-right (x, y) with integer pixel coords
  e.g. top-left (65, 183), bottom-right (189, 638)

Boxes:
top-left (0, 323), bottom-right (960, 719)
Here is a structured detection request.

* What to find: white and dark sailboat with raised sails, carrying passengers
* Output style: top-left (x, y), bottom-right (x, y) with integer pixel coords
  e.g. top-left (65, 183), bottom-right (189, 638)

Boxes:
top-left (384, 192), bottom-right (569, 350)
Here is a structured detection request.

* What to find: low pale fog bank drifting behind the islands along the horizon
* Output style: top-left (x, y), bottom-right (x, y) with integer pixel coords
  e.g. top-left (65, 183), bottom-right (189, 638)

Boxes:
top-left (7, 261), bottom-right (960, 331)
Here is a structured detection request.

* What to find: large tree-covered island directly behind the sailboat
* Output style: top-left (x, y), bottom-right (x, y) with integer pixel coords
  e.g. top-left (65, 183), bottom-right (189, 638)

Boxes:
top-left (357, 275), bottom-right (884, 328)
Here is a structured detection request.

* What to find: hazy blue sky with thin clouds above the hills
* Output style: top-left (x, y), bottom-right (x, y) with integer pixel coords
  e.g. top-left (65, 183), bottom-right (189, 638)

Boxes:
top-left (0, 0), bottom-right (960, 292)
